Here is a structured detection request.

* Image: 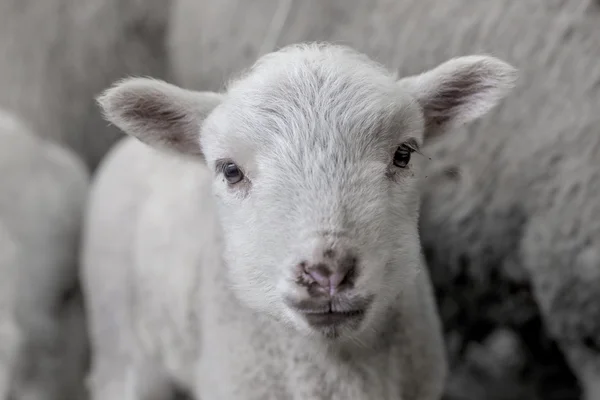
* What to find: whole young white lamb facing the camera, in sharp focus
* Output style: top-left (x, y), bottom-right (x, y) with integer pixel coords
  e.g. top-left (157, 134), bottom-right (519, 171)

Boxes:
top-left (82, 43), bottom-right (516, 400)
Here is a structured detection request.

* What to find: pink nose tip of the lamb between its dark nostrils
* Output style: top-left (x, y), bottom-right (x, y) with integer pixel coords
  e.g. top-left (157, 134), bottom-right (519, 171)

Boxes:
top-left (300, 252), bottom-right (357, 295)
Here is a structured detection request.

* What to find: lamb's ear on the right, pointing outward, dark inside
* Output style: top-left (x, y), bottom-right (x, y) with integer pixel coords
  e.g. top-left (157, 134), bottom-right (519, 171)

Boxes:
top-left (399, 55), bottom-right (517, 140)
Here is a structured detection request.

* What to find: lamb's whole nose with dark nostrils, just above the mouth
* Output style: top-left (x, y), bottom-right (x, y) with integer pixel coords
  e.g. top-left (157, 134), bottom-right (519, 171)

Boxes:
top-left (296, 248), bottom-right (358, 296)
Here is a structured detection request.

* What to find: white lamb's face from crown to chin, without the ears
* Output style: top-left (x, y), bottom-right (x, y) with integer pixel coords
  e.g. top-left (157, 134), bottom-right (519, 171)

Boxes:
top-left (201, 48), bottom-right (424, 336)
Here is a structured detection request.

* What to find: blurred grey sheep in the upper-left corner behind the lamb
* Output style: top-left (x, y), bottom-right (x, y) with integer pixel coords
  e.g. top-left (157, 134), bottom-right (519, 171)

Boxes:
top-left (0, 0), bottom-right (171, 170)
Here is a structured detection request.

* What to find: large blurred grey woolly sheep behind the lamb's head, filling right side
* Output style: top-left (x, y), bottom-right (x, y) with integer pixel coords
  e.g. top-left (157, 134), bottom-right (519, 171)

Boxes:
top-left (170, 0), bottom-right (600, 400)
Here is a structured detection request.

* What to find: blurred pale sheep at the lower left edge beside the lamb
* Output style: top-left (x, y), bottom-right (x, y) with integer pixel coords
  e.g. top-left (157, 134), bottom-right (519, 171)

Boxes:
top-left (0, 110), bottom-right (89, 400)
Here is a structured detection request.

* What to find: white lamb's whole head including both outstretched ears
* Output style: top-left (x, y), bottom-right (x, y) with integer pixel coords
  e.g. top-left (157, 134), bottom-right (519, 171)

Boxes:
top-left (99, 44), bottom-right (515, 340)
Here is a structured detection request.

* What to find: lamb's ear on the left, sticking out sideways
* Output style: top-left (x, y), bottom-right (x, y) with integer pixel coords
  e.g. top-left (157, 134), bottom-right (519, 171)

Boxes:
top-left (97, 78), bottom-right (223, 157)
